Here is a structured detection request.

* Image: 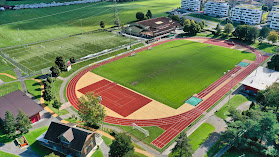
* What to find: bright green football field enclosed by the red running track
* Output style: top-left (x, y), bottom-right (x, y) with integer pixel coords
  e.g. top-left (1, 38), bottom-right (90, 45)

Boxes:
top-left (92, 40), bottom-right (255, 108)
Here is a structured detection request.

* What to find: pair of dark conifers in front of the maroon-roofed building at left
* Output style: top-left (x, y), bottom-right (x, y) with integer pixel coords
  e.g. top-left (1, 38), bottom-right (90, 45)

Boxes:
top-left (3, 110), bottom-right (32, 138)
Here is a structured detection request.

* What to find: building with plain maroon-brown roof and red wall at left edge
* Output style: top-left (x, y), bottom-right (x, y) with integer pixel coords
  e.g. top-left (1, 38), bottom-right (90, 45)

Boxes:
top-left (0, 90), bottom-right (44, 123)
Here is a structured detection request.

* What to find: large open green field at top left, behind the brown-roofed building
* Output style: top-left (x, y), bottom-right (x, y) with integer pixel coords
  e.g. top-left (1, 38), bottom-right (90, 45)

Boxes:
top-left (0, 0), bottom-right (180, 47)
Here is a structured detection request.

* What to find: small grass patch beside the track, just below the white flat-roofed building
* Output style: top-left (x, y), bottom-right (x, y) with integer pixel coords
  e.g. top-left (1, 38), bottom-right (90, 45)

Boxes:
top-left (215, 95), bottom-right (249, 119)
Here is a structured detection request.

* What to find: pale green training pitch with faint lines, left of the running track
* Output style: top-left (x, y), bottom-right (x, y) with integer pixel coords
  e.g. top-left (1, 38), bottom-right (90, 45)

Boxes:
top-left (2, 32), bottom-right (134, 71)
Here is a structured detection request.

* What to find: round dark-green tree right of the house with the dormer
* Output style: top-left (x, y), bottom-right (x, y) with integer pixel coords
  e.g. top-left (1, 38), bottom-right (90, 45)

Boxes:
top-left (109, 133), bottom-right (134, 157)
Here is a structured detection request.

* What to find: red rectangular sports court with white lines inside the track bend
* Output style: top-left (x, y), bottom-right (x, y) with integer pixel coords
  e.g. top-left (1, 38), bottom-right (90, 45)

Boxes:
top-left (78, 79), bottom-right (152, 117)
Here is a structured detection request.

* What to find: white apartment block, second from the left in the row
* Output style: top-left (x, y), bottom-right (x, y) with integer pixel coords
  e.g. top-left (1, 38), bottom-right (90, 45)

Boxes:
top-left (204, 1), bottom-right (230, 17)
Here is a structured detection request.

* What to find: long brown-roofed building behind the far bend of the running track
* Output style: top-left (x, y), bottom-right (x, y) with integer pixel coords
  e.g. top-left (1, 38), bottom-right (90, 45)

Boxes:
top-left (122, 17), bottom-right (179, 38)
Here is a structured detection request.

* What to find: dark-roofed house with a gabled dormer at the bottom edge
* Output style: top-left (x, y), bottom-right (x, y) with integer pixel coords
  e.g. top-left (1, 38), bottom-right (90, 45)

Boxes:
top-left (37, 122), bottom-right (96, 157)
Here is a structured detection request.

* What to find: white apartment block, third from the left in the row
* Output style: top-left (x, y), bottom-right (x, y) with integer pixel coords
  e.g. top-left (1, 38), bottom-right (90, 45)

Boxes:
top-left (230, 4), bottom-right (263, 25)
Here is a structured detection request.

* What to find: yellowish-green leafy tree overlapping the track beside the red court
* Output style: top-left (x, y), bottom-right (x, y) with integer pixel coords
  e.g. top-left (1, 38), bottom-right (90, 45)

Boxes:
top-left (78, 93), bottom-right (105, 125)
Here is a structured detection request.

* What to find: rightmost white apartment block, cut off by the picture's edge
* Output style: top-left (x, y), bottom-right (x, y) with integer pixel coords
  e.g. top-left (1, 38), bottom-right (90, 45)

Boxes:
top-left (267, 5), bottom-right (279, 29)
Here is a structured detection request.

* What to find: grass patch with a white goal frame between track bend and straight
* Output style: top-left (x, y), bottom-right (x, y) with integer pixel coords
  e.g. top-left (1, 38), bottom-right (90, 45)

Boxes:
top-left (119, 126), bottom-right (165, 143)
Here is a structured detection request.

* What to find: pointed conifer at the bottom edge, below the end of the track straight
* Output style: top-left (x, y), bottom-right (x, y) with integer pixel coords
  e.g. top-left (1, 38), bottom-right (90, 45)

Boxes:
top-left (171, 132), bottom-right (194, 157)
